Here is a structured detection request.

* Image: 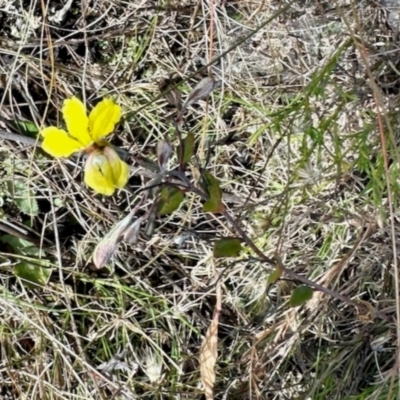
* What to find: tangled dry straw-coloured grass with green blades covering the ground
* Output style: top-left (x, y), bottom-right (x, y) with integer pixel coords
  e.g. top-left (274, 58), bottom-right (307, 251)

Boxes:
top-left (0, 0), bottom-right (400, 400)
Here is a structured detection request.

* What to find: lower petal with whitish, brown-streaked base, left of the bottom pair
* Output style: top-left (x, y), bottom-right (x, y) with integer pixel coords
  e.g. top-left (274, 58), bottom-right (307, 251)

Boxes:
top-left (85, 151), bottom-right (115, 196)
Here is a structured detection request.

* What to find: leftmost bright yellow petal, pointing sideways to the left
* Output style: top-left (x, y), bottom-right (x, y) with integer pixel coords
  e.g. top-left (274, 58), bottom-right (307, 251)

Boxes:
top-left (40, 126), bottom-right (84, 157)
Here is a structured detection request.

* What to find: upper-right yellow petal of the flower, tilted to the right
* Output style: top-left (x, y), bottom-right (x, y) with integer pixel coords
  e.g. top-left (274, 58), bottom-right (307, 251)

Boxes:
top-left (89, 99), bottom-right (121, 142)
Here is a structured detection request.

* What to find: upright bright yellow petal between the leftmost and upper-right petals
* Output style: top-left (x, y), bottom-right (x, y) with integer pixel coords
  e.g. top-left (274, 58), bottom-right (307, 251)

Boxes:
top-left (62, 97), bottom-right (93, 147)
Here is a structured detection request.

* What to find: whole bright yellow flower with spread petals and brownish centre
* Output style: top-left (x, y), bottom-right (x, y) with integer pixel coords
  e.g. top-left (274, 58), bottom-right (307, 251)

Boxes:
top-left (40, 97), bottom-right (129, 196)
